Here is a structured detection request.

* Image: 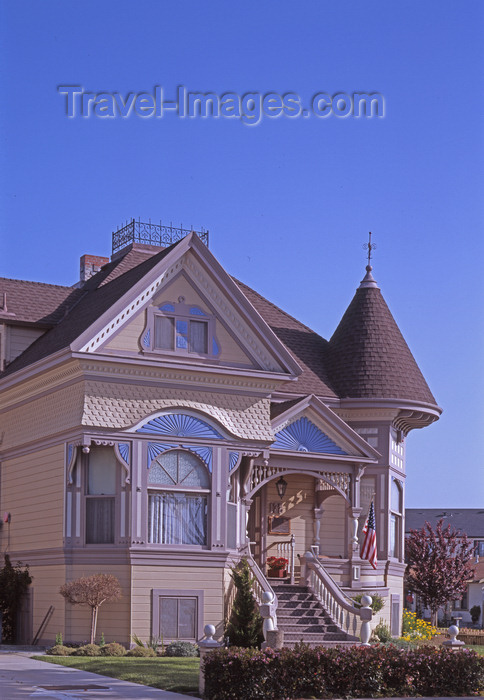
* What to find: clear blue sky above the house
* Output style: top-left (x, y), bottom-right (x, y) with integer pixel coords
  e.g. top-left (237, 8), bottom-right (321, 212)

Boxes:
top-left (0, 0), bottom-right (484, 508)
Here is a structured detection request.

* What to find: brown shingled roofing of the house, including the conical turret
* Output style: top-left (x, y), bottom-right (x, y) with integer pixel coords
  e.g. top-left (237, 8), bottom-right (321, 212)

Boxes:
top-left (0, 243), bottom-right (436, 404)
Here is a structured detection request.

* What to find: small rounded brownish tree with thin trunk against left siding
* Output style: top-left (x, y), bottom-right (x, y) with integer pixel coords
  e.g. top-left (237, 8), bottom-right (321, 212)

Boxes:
top-left (59, 574), bottom-right (121, 644)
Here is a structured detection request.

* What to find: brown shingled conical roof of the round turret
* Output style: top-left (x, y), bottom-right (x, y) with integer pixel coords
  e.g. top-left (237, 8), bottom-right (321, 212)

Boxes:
top-left (327, 266), bottom-right (436, 405)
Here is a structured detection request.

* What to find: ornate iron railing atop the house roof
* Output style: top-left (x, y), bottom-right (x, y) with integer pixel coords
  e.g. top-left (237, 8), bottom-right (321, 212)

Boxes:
top-left (112, 219), bottom-right (208, 255)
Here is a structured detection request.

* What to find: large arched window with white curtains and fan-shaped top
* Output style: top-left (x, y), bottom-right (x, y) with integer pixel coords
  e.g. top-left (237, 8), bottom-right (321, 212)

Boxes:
top-left (148, 450), bottom-right (210, 545)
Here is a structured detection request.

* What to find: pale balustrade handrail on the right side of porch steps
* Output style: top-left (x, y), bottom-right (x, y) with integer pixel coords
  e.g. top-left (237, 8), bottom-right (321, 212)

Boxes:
top-left (305, 552), bottom-right (373, 644)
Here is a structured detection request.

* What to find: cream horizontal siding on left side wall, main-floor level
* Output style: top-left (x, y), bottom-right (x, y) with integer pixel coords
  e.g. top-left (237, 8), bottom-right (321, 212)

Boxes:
top-left (0, 445), bottom-right (64, 552)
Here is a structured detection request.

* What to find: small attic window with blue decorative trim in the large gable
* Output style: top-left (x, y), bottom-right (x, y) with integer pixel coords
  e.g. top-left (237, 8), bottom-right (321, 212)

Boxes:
top-left (142, 297), bottom-right (219, 357)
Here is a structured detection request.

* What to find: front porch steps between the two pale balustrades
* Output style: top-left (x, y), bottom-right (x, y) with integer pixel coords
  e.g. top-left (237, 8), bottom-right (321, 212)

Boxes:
top-left (271, 581), bottom-right (358, 647)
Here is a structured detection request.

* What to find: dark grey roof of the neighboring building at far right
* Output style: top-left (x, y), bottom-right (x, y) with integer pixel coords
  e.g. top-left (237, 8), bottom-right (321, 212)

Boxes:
top-left (405, 508), bottom-right (484, 539)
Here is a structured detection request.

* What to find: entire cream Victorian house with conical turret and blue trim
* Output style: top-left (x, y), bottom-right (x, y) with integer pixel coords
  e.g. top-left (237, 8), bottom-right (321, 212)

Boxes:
top-left (0, 222), bottom-right (441, 643)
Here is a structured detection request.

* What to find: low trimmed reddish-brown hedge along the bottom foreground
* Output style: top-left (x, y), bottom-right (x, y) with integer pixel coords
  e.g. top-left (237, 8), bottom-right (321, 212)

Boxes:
top-left (204, 644), bottom-right (484, 700)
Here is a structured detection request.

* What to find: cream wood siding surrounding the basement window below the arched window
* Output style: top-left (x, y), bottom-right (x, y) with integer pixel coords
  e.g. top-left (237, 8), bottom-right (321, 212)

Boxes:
top-left (132, 566), bottom-right (224, 639)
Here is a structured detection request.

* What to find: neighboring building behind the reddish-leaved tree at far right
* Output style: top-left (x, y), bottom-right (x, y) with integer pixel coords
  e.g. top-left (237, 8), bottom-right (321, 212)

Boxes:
top-left (405, 508), bottom-right (484, 626)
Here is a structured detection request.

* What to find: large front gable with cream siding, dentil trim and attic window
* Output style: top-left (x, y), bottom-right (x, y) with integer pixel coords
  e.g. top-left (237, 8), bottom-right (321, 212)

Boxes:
top-left (73, 236), bottom-right (299, 376)
